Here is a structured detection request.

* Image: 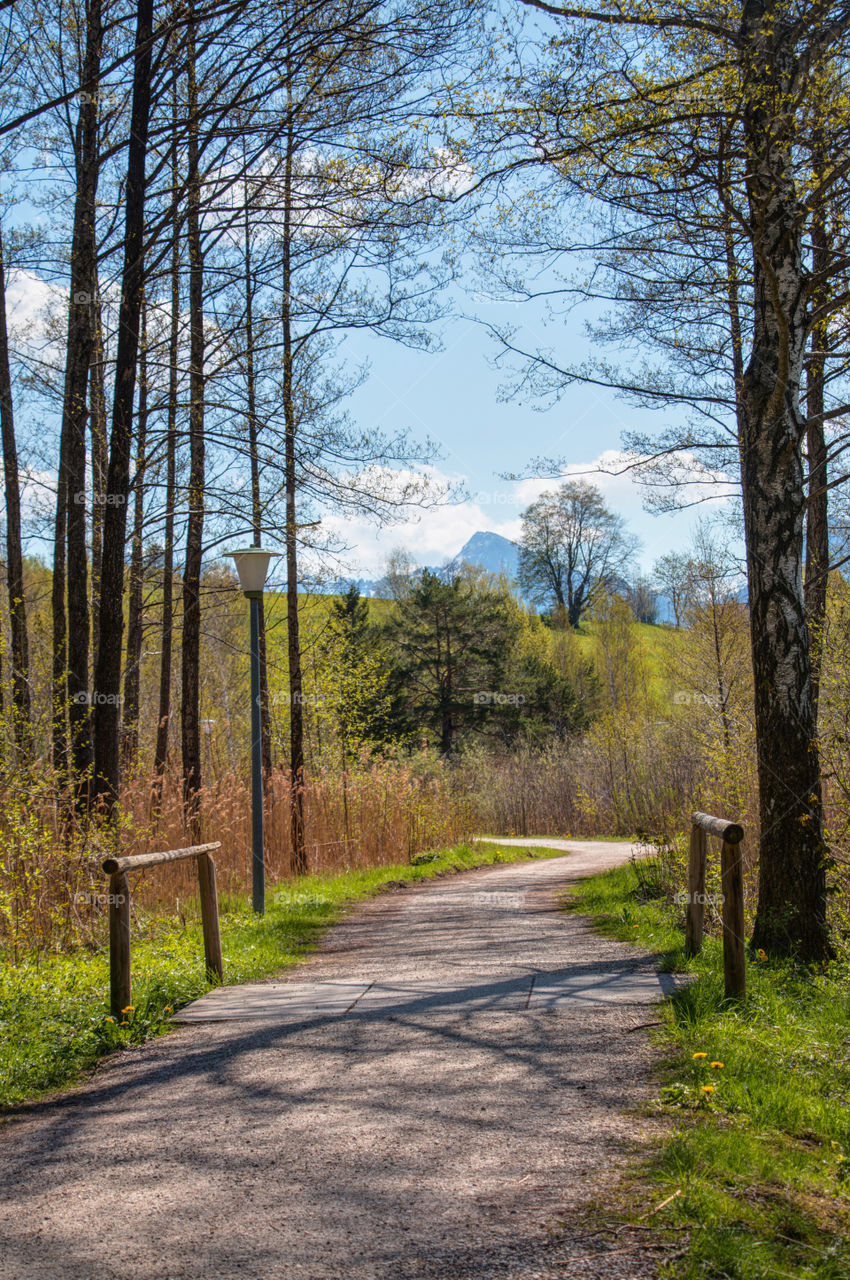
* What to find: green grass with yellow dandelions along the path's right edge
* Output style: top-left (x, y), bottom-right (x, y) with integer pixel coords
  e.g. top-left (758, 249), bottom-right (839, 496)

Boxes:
top-left (568, 867), bottom-right (850, 1280)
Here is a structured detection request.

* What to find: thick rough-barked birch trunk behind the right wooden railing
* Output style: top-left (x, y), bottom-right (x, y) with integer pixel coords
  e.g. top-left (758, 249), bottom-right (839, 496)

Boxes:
top-left (740, 0), bottom-right (830, 960)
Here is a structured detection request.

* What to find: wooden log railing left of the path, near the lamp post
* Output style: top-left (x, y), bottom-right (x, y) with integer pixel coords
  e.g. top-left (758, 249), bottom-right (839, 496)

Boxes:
top-left (102, 840), bottom-right (224, 1018)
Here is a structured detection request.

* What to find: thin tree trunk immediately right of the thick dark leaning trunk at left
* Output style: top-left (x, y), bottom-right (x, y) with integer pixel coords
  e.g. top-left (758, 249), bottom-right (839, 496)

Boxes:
top-left (122, 303), bottom-right (147, 772)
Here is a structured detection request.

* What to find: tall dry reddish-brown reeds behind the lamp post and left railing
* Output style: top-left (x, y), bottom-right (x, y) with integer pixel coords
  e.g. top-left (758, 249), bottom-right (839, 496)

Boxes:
top-left (0, 759), bottom-right (475, 960)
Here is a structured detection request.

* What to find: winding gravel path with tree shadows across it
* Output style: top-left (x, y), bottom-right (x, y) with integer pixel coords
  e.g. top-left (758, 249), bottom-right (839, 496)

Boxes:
top-left (0, 840), bottom-right (659, 1280)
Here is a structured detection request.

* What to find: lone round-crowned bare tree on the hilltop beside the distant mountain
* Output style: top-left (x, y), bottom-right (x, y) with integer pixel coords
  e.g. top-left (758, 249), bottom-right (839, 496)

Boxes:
top-left (520, 480), bottom-right (636, 627)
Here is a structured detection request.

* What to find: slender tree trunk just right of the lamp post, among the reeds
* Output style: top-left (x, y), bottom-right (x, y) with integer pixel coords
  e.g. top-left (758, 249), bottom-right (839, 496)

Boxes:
top-left (282, 115), bottom-right (307, 876)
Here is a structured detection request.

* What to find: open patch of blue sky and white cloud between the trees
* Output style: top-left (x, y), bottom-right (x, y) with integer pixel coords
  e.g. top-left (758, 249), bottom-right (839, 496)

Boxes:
top-left (332, 290), bottom-right (732, 577)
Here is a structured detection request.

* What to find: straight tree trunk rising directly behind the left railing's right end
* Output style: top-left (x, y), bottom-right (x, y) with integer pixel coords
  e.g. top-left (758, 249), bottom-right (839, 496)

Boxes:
top-left (180, 6), bottom-right (205, 844)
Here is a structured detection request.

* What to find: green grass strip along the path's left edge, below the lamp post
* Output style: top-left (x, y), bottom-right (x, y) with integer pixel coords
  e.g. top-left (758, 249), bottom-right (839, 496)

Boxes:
top-left (0, 844), bottom-right (563, 1108)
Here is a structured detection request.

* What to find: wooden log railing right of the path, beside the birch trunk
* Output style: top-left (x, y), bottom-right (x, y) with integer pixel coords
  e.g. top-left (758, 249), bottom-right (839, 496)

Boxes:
top-left (685, 813), bottom-right (746, 1000)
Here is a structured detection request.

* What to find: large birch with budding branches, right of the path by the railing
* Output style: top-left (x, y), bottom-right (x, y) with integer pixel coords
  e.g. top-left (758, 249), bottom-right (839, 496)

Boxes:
top-left (471, 0), bottom-right (850, 960)
